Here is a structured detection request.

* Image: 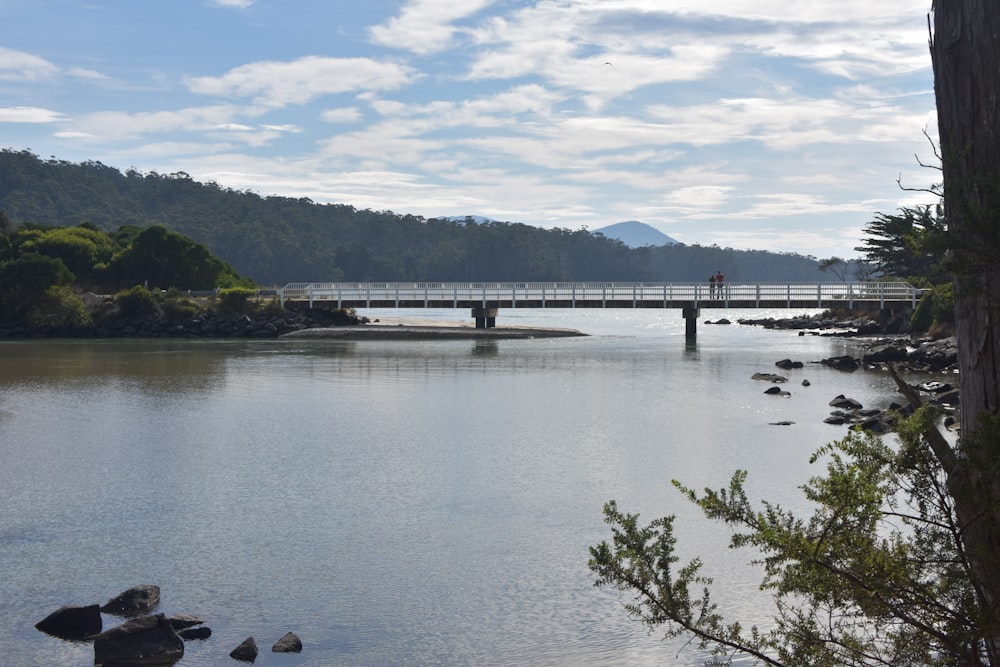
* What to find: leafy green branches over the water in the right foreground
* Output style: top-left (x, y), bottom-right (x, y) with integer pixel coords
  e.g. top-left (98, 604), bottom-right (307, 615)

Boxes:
top-left (589, 418), bottom-right (991, 667)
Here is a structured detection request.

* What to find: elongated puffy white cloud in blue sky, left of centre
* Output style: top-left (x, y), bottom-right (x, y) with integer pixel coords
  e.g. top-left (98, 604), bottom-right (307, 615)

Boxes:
top-left (187, 56), bottom-right (417, 108)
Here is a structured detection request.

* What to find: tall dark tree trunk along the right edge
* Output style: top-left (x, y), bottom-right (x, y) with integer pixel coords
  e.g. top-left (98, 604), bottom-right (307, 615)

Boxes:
top-left (931, 0), bottom-right (1000, 665)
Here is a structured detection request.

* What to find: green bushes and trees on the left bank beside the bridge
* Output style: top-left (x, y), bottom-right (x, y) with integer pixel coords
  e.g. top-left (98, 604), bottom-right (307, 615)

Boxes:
top-left (0, 218), bottom-right (294, 335)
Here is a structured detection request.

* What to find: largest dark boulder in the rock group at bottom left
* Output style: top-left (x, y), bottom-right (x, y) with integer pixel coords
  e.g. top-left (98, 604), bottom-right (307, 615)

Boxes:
top-left (94, 614), bottom-right (184, 665)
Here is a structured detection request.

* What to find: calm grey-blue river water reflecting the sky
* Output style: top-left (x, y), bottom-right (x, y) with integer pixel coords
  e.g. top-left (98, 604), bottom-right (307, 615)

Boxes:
top-left (0, 310), bottom-right (908, 667)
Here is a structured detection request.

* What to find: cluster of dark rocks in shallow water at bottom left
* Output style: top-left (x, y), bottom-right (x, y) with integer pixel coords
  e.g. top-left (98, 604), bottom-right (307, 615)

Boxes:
top-left (35, 584), bottom-right (302, 667)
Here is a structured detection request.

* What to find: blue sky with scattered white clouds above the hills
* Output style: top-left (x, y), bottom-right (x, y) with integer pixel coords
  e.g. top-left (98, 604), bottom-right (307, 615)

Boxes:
top-left (0, 0), bottom-right (940, 259)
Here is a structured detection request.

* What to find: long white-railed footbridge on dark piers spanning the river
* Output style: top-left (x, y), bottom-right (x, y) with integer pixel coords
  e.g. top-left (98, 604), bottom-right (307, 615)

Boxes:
top-left (278, 282), bottom-right (923, 334)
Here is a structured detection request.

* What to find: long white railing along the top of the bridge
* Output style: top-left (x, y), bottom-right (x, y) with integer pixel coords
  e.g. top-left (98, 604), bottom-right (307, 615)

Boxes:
top-left (278, 282), bottom-right (922, 308)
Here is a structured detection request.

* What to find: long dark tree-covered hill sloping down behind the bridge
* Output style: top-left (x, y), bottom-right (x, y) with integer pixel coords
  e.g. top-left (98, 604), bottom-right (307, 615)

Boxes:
top-left (0, 150), bottom-right (828, 285)
